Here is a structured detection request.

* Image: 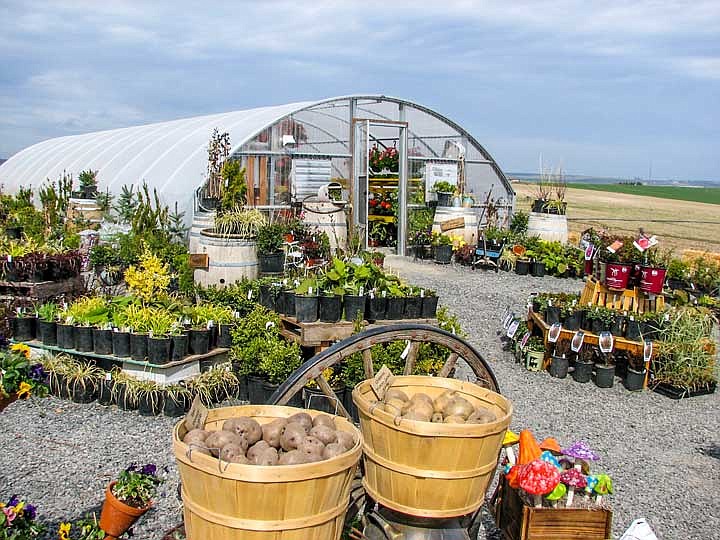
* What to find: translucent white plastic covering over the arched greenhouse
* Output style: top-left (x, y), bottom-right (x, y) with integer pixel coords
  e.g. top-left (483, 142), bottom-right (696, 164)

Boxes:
top-left (0, 96), bottom-right (513, 220)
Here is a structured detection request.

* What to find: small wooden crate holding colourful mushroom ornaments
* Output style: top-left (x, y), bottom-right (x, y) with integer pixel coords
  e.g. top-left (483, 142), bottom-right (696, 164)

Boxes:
top-left (495, 476), bottom-right (612, 540)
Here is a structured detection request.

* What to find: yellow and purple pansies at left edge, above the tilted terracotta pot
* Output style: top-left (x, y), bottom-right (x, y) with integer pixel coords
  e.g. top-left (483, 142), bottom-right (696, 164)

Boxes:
top-left (0, 343), bottom-right (48, 399)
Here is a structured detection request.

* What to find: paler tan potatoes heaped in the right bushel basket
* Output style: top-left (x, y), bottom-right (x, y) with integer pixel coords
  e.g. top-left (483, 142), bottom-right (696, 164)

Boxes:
top-left (381, 388), bottom-right (497, 424)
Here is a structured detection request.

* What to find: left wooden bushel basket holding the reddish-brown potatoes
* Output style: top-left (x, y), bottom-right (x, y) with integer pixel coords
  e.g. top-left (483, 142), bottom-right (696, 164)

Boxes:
top-left (173, 405), bottom-right (362, 540)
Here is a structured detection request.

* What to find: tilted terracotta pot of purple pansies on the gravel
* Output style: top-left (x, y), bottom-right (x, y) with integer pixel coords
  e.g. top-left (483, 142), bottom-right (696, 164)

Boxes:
top-left (100, 463), bottom-right (163, 538)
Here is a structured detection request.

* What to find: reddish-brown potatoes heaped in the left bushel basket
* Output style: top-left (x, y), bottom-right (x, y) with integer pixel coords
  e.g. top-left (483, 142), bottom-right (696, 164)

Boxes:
top-left (183, 412), bottom-right (357, 466)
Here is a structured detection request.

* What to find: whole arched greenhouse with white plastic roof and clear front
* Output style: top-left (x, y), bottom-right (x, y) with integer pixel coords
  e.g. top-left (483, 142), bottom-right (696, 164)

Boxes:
top-left (0, 95), bottom-right (513, 253)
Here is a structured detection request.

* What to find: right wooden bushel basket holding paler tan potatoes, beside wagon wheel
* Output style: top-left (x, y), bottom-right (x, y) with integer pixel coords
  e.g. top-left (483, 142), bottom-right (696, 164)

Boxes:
top-left (353, 376), bottom-right (513, 518)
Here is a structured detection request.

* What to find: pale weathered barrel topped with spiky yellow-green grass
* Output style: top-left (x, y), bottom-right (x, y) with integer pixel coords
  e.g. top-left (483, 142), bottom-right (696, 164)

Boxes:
top-left (195, 229), bottom-right (258, 287)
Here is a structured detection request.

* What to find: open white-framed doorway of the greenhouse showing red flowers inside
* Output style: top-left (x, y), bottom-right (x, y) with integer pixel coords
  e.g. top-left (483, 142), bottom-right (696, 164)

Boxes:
top-left (351, 118), bottom-right (408, 255)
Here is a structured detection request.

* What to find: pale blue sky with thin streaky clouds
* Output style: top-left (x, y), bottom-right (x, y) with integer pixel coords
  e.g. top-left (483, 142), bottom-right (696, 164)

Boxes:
top-left (0, 0), bottom-right (720, 181)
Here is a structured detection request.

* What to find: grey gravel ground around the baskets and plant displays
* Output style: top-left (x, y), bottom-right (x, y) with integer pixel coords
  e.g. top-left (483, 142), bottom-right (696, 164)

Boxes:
top-left (0, 257), bottom-right (720, 540)
